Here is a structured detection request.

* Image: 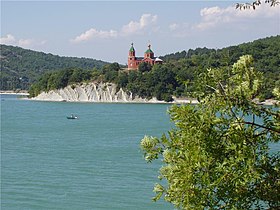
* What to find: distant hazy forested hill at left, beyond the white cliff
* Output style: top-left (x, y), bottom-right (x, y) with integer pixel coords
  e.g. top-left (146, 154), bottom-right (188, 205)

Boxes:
top-left (0, 45), bottom-right (108, 90)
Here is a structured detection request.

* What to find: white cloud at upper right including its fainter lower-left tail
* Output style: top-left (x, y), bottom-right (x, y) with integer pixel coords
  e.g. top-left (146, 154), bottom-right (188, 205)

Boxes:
top-left (169, 4), bottom-right (280, 37)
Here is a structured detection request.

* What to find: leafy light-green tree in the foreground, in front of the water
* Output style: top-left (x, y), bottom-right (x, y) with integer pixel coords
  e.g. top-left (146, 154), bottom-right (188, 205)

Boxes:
top-left (141, 56), bottom-right (280, 209)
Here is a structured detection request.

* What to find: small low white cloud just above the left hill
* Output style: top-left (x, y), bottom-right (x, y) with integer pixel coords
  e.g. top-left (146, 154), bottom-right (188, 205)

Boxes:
top-left (0, 34), bottom-right (46, 48)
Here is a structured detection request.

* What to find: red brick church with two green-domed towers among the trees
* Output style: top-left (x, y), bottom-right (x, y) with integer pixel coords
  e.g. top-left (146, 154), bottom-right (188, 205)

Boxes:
top-left (127, 43), bottom-right (163, 70)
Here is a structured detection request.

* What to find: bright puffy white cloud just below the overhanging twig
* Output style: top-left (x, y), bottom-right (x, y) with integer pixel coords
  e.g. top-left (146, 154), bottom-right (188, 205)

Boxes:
top-left (193, 4), bottom-right (280, 30)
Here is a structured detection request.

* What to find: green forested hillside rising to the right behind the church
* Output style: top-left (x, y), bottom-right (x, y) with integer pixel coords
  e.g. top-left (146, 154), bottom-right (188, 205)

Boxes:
top-left (160, 35), bottom-right (280, 98)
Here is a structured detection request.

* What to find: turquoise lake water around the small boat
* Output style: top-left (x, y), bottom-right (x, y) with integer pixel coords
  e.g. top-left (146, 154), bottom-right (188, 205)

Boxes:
top-left (1, 95), bottom-right (173, 210)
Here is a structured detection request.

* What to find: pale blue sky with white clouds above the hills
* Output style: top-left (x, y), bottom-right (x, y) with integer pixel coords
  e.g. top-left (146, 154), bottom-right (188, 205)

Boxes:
top-left (0, 0), bottom-right (280, 64)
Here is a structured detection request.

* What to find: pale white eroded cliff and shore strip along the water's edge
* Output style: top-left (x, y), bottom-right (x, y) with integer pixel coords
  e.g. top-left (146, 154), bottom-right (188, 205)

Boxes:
top-left (20, 82), bottom-right (279, 106)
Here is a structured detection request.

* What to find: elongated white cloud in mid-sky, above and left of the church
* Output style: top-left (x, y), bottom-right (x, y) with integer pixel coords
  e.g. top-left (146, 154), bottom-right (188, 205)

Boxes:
top-left (70, 14), bottom-right (158, 43)
